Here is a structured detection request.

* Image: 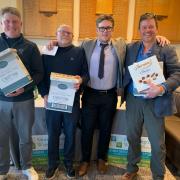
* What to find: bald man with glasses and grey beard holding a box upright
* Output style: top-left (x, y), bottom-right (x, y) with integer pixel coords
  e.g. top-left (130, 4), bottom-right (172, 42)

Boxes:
top-left (39, 25), bottom-right (89, 179)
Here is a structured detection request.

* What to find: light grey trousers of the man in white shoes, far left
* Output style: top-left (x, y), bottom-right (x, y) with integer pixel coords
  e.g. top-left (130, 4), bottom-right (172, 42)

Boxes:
top-left (0, 99), bottom-right (34, 174)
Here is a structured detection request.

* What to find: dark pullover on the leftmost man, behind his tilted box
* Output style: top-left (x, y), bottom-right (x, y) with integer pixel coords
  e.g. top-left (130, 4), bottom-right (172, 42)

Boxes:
top-left (0, 33), bottom-right (43, 102)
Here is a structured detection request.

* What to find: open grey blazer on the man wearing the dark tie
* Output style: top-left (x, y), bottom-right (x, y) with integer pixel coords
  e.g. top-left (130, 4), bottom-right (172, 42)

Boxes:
top-left (81, 38), bottom-right (126, 88)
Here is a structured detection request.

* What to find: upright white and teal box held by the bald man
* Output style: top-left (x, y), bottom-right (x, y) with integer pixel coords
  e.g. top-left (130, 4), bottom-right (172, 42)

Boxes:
top-left (46, 72), bottom-right (79, 113)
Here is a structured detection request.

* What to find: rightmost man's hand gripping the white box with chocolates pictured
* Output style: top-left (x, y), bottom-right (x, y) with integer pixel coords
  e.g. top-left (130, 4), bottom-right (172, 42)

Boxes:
top-left (141, 82), bottom-right (164, 98)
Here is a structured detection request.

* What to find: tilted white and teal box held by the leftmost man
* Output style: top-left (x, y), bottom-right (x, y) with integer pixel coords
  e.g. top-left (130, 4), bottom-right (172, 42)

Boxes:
top-left (0, 48), bottom-right (32, 95)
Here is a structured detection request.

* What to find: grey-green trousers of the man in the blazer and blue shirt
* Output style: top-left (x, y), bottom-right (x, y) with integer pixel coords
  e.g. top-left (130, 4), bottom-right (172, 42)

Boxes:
top-left (126, 94), bottom-right (166, 179)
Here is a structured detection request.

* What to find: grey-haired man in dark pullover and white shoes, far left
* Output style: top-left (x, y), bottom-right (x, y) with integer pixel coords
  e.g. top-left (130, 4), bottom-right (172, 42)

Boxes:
top-left (0, 7), bottom-right (43, 180)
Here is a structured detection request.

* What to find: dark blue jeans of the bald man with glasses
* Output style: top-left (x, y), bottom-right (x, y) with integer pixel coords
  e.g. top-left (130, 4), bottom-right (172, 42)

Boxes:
top-left (46, 104), bottom-right (80, 169)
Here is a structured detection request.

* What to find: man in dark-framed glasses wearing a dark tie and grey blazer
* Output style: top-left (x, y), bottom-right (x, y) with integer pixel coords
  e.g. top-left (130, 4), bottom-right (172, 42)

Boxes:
top-left (79, 15), bottom-right (126, 176)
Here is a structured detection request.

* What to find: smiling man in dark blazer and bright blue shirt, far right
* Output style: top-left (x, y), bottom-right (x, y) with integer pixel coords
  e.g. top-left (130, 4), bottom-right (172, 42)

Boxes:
top-left (122, 13), bottom-right (180, 180)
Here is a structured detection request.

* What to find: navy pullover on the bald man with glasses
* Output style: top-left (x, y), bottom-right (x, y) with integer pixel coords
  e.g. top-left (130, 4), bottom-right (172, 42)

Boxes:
top-left (39, 45), bottom-right (89, 101)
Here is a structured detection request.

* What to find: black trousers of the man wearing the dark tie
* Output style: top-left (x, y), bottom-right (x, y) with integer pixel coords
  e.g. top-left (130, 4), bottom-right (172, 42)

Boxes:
top-left (81, 89), bottom-right (117, 162)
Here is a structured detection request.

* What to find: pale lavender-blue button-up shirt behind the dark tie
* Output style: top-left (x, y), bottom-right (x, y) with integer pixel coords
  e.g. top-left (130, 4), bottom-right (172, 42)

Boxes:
top-left (88, 40), bottom-right (118, 90)
